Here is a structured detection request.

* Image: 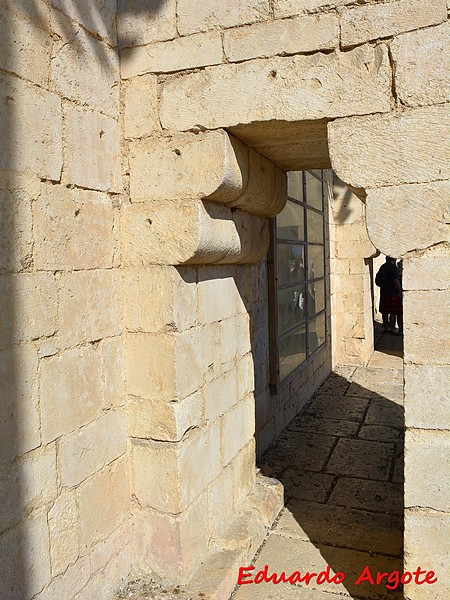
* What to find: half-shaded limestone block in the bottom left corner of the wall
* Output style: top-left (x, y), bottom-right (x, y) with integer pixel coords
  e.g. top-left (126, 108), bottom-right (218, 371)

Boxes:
top-left (0, 509), bottom-right (51, 598)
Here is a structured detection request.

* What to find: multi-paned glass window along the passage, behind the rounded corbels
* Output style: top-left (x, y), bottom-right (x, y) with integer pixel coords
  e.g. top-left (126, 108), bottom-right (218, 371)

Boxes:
top-left (269, 170), bottom-right (328, 390)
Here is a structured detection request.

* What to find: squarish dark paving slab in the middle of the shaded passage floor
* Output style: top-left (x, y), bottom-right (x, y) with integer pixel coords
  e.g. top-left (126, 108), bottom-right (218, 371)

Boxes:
top-left (325, 438), bottom-right (394, 481)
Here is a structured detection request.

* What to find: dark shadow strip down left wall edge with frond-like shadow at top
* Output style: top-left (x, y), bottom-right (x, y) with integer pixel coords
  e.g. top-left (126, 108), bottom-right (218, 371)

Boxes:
top-left (0, 0), bottom-right (166, 600)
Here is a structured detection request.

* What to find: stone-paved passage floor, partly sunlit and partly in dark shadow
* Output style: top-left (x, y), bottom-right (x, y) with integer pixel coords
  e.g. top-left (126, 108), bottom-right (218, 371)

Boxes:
top-left (234, 333), bottom-right (404, 600)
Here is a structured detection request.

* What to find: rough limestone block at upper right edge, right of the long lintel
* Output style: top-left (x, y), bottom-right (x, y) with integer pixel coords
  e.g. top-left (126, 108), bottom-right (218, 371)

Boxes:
top-left (391, 24), bottom-right (450, 106)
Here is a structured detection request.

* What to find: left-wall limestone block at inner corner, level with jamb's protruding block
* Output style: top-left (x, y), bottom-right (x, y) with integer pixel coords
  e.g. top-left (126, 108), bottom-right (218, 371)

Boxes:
top-left (58, 410), bottom-right (127, 487)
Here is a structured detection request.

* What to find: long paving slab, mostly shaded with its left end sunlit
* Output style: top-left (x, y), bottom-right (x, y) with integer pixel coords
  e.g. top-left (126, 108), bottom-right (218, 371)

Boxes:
top-left (276, 499), bottom-right (403, 556)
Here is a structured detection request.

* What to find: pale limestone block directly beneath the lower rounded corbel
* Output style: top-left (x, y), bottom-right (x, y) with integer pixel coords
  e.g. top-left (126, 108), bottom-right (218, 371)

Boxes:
top-left (124, 266), bottom-right (197, 332)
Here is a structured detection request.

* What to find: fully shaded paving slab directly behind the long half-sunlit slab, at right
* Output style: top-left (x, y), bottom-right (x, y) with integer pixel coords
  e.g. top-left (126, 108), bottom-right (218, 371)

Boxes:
top-left (329, 477), bottom-right (403, 515)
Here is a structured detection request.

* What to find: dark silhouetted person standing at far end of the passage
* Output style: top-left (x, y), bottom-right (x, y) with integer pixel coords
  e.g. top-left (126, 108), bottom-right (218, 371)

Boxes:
top-left (375, 256), bottom-right (403, 335)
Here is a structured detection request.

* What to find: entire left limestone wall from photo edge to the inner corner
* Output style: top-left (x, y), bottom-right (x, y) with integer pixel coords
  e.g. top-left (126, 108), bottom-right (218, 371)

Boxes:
top-left (0, 0), bottom-right (131, 600)
